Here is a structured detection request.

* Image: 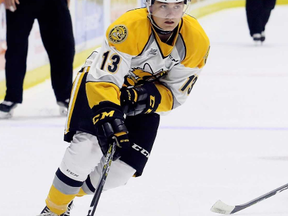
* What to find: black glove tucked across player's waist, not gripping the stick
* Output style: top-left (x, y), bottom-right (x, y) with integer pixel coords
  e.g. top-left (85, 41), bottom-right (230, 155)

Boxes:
top-left (120, 82), bottom-right (161, 116)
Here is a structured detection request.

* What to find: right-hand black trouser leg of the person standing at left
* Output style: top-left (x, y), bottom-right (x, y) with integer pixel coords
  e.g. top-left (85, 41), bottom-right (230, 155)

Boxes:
top-left (38, 0), bottom-right (75, 108)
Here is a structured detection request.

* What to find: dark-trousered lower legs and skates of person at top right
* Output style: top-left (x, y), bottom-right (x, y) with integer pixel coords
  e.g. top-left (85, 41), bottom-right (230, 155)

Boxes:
top-left (246, 0), bottom-right (276, 44)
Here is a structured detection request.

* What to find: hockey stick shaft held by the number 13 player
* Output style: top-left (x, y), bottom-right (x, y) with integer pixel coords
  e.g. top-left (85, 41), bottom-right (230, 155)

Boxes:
top-left (87, 137), bottom-right (117, 216)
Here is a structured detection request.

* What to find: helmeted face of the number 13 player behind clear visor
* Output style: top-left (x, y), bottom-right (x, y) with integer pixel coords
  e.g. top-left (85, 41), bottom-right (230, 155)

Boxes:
top-left (150, 1), bottom-right (185, 31)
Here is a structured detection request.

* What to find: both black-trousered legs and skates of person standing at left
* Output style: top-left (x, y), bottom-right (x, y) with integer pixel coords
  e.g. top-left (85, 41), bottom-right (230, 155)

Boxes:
top-left (0, 0), bottom-right (75, 119)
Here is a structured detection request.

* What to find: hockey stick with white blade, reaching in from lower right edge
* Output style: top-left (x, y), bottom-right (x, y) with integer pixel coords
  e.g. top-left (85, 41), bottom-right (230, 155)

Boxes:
top-left (210, 184), bottom-right (288, 215)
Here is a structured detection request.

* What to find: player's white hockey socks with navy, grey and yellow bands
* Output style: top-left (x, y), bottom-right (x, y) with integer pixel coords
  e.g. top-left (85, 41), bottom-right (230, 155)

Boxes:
top-left (46, 132), bottom-right (136, 215)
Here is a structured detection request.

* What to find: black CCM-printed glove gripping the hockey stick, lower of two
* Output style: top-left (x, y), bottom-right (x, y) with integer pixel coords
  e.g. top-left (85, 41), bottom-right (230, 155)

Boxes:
top-left (92, 102), bottom-right (130, 160)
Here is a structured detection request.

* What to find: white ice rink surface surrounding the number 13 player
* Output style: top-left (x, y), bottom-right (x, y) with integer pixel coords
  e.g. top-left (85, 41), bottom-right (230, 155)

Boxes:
top-left (0, 6), bottom-right (288, 216)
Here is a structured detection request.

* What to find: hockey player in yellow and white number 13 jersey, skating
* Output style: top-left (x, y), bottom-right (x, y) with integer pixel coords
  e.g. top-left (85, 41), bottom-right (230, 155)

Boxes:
top-left (40, 0), bottom-right (209, 216)
